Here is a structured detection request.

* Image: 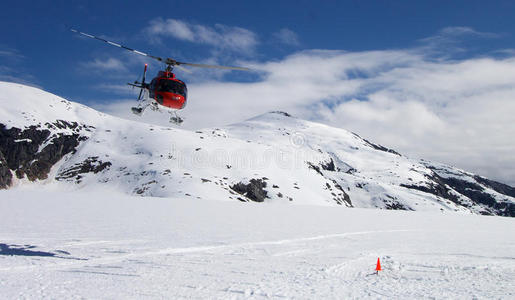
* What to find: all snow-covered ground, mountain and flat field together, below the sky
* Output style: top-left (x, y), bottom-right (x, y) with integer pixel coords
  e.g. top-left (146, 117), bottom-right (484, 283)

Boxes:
top-left (0, 82), bottom-right (515, 299)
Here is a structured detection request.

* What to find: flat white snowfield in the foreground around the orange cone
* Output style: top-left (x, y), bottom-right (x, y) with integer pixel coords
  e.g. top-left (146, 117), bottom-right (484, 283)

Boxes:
top-left (0, 189), bottom-right (515, 299)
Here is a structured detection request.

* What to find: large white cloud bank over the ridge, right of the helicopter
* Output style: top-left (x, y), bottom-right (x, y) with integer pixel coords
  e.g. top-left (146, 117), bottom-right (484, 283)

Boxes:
top-left (94, 29), bottom-right (515, 185)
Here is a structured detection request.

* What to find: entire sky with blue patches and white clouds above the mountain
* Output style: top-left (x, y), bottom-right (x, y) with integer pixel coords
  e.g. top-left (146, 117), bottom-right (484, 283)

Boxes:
top-left (0, 1), bottom-right (515, 185)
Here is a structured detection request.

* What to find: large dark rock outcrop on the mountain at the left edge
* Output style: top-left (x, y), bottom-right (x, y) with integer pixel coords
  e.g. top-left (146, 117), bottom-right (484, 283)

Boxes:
top-left (0, 120), bottom-right (87, 188)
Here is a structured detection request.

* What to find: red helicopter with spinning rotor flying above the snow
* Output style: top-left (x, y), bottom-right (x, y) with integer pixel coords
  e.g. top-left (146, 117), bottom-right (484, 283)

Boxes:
top-left (70, 29), bottom-right (250, 125)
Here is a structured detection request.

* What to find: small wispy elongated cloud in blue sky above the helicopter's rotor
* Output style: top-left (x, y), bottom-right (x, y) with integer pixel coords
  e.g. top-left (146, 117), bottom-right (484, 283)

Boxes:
top-left (145, 19), bottom-right (258, 54)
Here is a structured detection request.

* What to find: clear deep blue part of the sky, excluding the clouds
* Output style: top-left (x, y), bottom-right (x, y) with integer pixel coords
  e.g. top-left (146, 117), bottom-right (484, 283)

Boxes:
top-left (0, 1), bottom-right (515, 102)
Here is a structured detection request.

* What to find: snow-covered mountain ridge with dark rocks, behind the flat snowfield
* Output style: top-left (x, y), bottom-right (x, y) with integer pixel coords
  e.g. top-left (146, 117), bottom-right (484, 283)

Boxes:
top-left (0, 82), bottom-right (515, 217)
